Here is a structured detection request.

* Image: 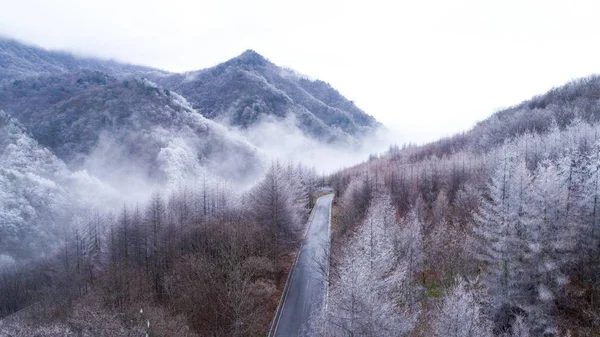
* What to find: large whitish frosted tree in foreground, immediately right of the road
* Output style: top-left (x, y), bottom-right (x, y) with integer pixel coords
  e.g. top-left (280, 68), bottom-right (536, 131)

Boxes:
top-left (328, 193), bottom-right (418, 336)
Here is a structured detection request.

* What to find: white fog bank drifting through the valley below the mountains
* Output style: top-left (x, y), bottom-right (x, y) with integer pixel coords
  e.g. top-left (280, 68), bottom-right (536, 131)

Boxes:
top-left (71, 118), bottom-right (384, 211)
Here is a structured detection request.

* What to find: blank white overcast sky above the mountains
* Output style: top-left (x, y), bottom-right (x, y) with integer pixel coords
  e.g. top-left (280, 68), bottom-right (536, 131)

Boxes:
top-left (0, 0), bottom-right (600, 143)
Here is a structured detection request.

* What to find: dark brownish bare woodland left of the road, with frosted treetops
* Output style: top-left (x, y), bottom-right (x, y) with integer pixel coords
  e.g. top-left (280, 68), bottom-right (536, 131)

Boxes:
top-left (0, 163), bottom-right (317, 336)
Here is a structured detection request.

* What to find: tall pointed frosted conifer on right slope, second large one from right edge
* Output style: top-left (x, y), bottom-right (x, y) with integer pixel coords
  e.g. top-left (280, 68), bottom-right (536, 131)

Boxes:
top-left (474, 152), bottom-right (529, 330)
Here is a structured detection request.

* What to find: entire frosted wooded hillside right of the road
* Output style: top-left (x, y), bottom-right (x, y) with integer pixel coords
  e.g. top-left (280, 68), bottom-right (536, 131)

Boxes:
top-left (327, 76), bottom-right (600, 337)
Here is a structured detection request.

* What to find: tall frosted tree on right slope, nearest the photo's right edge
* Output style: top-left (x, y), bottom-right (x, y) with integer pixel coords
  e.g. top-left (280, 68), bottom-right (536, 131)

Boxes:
top-left (521, 153), bottom-right (586, 331)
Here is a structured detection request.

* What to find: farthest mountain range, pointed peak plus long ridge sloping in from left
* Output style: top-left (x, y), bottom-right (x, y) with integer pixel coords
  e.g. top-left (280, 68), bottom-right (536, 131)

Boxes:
top-left (0, 40), bottom-right (381, 147)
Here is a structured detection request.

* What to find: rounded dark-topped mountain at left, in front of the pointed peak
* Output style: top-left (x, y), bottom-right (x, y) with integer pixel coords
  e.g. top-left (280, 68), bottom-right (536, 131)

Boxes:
top-left (0, 70), bottom-right (262, 181)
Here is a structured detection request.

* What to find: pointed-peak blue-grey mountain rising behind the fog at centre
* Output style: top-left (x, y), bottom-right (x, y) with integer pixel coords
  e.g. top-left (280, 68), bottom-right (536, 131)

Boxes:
top-left (150, 50), bottom-right (380, 142)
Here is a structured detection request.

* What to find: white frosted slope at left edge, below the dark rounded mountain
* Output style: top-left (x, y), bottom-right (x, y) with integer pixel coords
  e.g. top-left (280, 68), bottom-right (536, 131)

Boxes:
top-left (0, 110), bottom-right (119, 260)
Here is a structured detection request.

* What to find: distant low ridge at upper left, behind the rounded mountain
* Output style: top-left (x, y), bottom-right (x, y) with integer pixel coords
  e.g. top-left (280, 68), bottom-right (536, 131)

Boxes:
top-left (0, 38), bottom-right (167, 84)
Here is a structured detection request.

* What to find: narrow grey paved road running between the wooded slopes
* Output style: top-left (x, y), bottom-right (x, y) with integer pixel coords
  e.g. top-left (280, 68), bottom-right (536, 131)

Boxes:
top-left (269, 194), bottom-right (333, 337)
